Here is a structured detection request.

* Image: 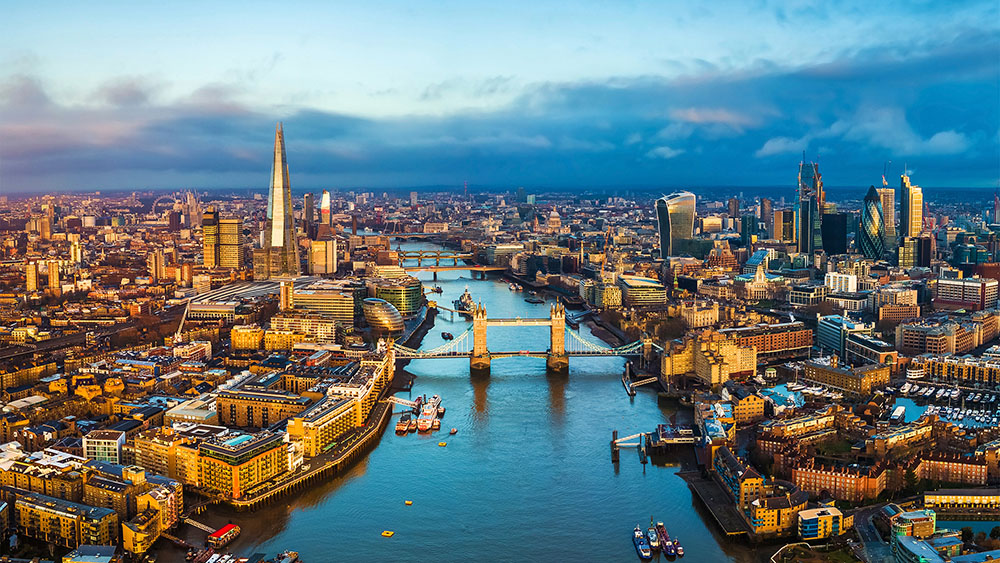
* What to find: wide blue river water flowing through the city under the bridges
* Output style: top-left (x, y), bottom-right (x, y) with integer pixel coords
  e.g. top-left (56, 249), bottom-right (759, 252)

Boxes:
top-left (161, 243), bottom-right (770, 563)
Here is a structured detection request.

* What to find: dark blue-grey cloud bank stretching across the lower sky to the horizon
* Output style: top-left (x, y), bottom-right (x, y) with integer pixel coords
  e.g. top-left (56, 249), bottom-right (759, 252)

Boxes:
top-left (0, 32), bottom-right (1000, 191)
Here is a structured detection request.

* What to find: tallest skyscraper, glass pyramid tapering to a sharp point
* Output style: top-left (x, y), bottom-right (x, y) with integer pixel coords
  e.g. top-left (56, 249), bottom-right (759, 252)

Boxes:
top-left (254, 123), bottom-right (299, 279)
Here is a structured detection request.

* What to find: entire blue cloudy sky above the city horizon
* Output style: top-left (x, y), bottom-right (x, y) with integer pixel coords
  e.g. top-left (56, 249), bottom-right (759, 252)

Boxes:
top-left (0, 0), bottom-right (1000, 193)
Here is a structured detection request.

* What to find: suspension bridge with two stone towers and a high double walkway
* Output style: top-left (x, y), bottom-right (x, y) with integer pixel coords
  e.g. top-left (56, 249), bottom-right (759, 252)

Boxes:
top-left (393, 304), bottom-right (662, 374)
